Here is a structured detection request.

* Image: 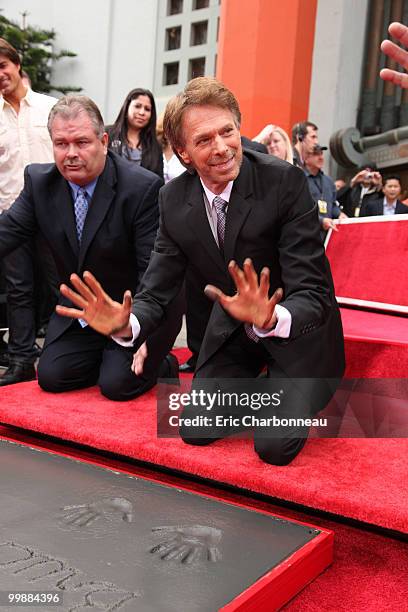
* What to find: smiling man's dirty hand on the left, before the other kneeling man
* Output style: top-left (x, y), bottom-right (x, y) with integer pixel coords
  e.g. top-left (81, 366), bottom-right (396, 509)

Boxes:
top-left (56, 272), bottom-right (132, 338)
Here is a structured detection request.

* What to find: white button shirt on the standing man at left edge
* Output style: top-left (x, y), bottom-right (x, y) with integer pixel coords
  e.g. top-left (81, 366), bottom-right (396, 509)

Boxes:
top-left (0, 89), bottom-right (57, 212)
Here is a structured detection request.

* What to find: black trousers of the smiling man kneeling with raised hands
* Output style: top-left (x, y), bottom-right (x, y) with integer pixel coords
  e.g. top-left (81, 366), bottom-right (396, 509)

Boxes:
top-left (180, 326), bottom-right (311, 465)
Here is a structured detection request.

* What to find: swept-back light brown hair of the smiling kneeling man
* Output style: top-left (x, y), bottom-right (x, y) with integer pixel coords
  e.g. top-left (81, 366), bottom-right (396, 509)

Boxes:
top-left (163, 77), bottom-right (241, 150)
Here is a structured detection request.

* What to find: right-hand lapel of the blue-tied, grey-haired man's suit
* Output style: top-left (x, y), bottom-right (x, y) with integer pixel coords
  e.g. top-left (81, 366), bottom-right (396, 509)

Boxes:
top-left (78, 156), bottom-right (116, 270)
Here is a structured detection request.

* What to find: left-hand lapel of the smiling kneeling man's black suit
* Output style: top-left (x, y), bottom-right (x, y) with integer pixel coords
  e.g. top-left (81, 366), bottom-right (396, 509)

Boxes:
top-left (187, 176), bottom-right (225, 273)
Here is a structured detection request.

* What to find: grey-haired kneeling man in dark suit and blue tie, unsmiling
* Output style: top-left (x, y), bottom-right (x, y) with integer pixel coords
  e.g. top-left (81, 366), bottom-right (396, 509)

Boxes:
top-left (0, 96), bottom-right (181, 400)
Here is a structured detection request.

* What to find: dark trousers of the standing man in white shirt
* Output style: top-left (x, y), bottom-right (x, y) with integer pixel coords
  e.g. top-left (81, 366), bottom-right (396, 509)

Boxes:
top-left (3, 239), bottom-right (58, 364)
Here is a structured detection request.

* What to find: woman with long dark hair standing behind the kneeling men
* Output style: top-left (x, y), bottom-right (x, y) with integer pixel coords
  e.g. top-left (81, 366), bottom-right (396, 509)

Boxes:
top-left (107, 88), bottom-right (163, 178)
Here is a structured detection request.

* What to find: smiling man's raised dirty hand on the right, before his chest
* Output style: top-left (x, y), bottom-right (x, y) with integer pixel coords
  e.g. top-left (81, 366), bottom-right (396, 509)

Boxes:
top-left (204, 259), bottom-right (283, 329)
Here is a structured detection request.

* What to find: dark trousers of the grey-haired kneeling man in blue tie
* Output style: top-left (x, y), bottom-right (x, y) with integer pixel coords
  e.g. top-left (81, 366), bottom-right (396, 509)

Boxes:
top-left (37, 298), bottom-right (182, 401)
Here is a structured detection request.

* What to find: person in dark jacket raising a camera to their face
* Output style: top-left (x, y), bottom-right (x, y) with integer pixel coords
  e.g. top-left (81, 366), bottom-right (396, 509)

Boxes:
top-left (337, 166), bottom-right (382, 217)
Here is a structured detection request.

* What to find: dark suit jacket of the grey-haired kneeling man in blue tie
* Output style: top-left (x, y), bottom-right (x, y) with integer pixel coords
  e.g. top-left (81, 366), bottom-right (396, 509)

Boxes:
top-left (0, 153), bottom-right (162, 342)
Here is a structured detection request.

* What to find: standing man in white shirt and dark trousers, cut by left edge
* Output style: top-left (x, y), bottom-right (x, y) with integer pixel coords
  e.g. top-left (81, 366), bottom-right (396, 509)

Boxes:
top-left (0, 38), bottom-right (57, 386)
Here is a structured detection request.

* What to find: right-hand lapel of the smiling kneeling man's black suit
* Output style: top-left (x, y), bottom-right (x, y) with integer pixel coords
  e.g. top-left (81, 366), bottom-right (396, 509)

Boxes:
top-left (224, 157), bottom-right (252, 262)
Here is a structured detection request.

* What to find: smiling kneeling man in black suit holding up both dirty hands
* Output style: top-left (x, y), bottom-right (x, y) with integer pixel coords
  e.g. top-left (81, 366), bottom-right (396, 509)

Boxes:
top-left (58, 77), bottom-right (344, 465)
